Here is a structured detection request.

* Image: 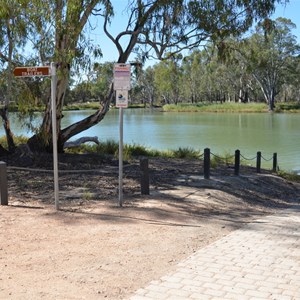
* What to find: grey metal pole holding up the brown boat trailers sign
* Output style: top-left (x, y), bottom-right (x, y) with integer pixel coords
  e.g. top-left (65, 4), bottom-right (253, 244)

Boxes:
top-left (51, 62), bottom-right (59, 210)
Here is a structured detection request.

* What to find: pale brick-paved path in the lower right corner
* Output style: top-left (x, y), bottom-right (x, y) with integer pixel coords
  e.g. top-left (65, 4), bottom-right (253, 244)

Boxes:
top-left (130, 207), bottom-right (300, 300)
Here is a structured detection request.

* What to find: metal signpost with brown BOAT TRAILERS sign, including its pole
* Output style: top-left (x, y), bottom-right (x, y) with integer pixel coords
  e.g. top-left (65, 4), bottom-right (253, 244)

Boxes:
top-left (14, 63), bottom-right (59, 210)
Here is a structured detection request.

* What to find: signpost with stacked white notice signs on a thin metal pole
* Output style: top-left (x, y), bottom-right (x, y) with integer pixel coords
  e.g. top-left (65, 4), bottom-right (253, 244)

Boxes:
top-left (114, 64), bottom-right (131, 207)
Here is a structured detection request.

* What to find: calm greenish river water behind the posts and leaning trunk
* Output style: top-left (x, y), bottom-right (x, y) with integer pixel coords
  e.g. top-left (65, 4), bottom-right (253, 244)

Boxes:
top-left (0, 109), bottom-right (300, 170)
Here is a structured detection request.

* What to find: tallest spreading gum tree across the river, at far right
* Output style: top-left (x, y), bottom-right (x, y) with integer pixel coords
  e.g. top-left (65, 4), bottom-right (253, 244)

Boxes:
top-left (240, 18), bottom-right (300, 111)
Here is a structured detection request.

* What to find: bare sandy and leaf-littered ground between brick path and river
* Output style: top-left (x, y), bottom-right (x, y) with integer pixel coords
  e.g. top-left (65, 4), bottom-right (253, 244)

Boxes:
top-left (0, 154), bottom-right (299, 299)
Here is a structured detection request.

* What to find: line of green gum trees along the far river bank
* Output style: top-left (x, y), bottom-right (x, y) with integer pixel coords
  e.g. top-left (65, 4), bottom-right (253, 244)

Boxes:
top-left (67, 18), bottom-right (300, 110)
